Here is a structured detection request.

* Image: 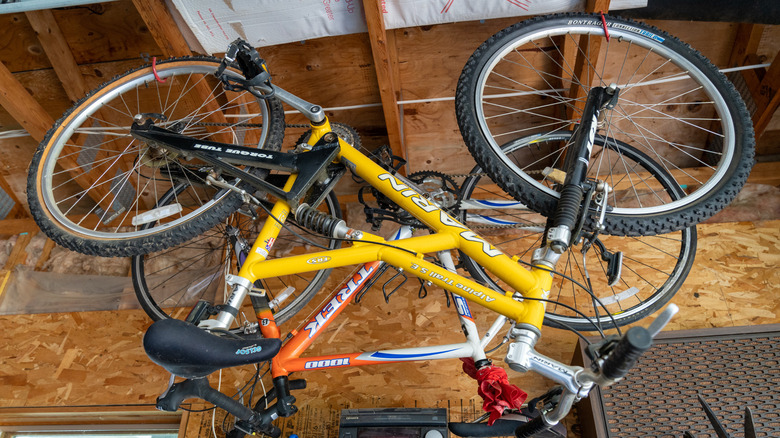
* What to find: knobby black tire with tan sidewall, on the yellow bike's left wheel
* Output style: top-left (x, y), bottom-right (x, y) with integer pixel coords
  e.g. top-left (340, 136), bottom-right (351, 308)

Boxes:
top-left (27, 56), bottom-right (285, 257)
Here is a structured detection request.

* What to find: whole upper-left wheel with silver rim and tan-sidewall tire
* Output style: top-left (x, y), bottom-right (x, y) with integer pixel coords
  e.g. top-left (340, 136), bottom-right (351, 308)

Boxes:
top-left (27, 57), bottom-right (284, 257)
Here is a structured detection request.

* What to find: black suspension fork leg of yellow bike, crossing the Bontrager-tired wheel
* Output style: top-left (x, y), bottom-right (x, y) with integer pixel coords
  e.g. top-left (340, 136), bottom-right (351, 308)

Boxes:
top-left (547, 85), bottom-right (618, 255)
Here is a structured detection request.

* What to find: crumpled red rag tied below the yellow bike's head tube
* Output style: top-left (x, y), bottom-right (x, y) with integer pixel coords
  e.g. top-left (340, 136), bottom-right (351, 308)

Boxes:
top-left (461, 358), bottom-right (528, 426)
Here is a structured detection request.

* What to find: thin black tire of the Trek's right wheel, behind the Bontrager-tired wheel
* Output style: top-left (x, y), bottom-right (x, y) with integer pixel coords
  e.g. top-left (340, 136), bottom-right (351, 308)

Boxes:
top-left (460, 136), bottom-right (697, 331)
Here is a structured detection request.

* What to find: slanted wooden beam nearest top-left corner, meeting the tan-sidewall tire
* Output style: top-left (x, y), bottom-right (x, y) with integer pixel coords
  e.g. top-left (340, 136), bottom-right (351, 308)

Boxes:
top-left (25, 9), bottom-right (89, 102)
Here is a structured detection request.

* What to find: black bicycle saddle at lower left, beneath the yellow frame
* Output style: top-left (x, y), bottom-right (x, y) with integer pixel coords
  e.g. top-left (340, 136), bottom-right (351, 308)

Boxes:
top-left (144, 319), bottom-right (282, 379)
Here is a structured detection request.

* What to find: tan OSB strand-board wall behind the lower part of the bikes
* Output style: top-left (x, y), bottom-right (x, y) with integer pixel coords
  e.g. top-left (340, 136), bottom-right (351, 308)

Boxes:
top-left (0, 220), bottom-right (780, 407)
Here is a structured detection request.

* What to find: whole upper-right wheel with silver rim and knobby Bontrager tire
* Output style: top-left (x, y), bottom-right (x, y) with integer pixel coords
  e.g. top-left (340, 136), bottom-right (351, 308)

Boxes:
top-left (456, 14), bottom-right (755, 235)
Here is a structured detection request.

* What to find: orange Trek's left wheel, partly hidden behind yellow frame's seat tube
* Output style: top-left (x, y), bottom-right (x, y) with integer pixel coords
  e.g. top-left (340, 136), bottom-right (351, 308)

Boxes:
top-left (131, 186), bottom-right (341, 324)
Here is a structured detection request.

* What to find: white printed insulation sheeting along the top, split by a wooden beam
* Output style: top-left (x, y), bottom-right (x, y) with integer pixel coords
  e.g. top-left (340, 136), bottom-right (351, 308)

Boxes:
top-left (172, 0), bottom-right (647, 54)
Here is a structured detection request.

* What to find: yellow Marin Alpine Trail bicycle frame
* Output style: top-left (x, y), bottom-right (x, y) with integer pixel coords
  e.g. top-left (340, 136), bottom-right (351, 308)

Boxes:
top-left (232, 120), bottom-right (552, 366)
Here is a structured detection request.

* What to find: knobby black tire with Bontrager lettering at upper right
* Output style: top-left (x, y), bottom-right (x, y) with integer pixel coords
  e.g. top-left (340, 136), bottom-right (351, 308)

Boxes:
top-left (456, 13), bottom-right (755, 236)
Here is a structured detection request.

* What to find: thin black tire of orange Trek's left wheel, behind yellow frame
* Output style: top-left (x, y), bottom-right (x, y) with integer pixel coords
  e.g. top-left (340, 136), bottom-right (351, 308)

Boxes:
top-left (130, 191), bottom-right (342, 324)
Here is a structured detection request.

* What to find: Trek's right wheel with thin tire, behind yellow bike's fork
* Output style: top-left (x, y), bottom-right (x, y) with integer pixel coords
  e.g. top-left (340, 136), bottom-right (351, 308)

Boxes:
top-left (461, 132), bottom-right (696, 331)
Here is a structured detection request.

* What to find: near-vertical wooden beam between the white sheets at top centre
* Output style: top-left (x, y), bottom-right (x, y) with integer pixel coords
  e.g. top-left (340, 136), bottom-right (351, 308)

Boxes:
top-left (363, 0), bottom-right (407, 170)
